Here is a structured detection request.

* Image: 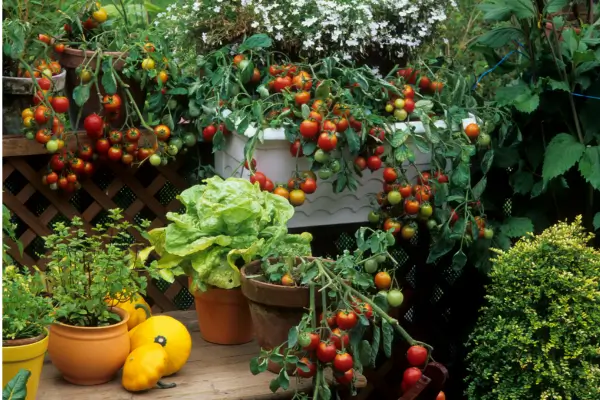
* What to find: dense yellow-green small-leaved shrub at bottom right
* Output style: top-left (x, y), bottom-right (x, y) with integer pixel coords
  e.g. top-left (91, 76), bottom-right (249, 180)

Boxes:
top-left (467, 217), bottom-right (600, 400)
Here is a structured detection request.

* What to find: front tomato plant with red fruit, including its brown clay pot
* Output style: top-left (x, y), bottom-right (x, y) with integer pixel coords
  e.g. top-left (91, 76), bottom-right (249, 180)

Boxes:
top-left (246, 228), bottom-right (433, 399)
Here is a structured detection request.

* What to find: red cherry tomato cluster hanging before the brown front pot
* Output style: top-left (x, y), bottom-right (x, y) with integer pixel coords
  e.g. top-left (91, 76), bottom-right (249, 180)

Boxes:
top-left (290, 300), bottom-right (373, 385)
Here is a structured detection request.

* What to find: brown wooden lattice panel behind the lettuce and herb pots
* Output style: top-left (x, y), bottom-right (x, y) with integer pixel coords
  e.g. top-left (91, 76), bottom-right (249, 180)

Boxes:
top-left (2, 141), bottom-right (193, 312)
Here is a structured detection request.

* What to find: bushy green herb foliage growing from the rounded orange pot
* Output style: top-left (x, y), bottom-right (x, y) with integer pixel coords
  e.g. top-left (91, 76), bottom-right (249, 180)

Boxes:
top-left (44, 209), bottom-right (150, 327)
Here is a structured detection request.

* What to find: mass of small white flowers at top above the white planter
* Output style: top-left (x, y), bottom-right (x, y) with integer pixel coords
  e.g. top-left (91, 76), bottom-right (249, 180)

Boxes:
top-left (156, 0), bottom-right (451, 60)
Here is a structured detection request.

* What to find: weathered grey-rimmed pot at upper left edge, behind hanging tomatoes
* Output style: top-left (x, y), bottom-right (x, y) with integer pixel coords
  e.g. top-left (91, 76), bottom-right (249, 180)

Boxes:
top-left (2, 69), bottom-right (67, 136)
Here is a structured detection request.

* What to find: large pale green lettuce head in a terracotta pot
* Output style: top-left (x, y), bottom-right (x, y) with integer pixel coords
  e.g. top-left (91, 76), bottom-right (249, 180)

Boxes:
top-left (149, 176), bottom-right (312, 290)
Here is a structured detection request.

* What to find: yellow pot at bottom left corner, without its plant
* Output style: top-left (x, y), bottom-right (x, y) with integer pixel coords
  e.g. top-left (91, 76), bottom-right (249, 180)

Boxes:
top-left (2, 331), bottom-right (48, 400)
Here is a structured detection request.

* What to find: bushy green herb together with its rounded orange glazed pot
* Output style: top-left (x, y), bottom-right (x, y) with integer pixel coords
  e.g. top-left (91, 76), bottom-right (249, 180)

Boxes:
top-left (45, 209), bottom-right (149, 385)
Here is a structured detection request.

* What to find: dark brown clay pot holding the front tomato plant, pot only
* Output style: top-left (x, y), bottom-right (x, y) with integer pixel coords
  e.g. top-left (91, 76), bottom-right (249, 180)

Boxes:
top-left (240, 257), bottom-right (328, 373)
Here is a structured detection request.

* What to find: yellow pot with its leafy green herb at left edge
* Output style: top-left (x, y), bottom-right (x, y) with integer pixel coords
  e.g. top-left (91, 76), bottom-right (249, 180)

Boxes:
top-left (2, 265), bottom-right (54, 400)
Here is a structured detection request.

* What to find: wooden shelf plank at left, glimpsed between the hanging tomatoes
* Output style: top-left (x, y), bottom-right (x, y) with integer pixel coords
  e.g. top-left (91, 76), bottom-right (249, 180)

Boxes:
top-left (2, 130), bottom-right (156, 157)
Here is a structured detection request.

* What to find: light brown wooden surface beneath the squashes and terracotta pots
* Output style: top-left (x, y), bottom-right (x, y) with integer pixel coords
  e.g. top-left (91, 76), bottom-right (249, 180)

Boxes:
top-left (37, 311), bottom-right (366, 400)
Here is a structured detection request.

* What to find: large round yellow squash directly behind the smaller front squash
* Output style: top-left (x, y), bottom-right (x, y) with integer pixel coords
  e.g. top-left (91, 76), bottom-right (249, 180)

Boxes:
top-left (130, 305), bottom-right (192, 376)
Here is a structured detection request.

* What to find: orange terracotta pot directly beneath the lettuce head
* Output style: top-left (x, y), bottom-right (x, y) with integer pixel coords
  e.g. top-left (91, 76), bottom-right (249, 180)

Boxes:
top-left (190, 278), bottom-right (254, 344)
